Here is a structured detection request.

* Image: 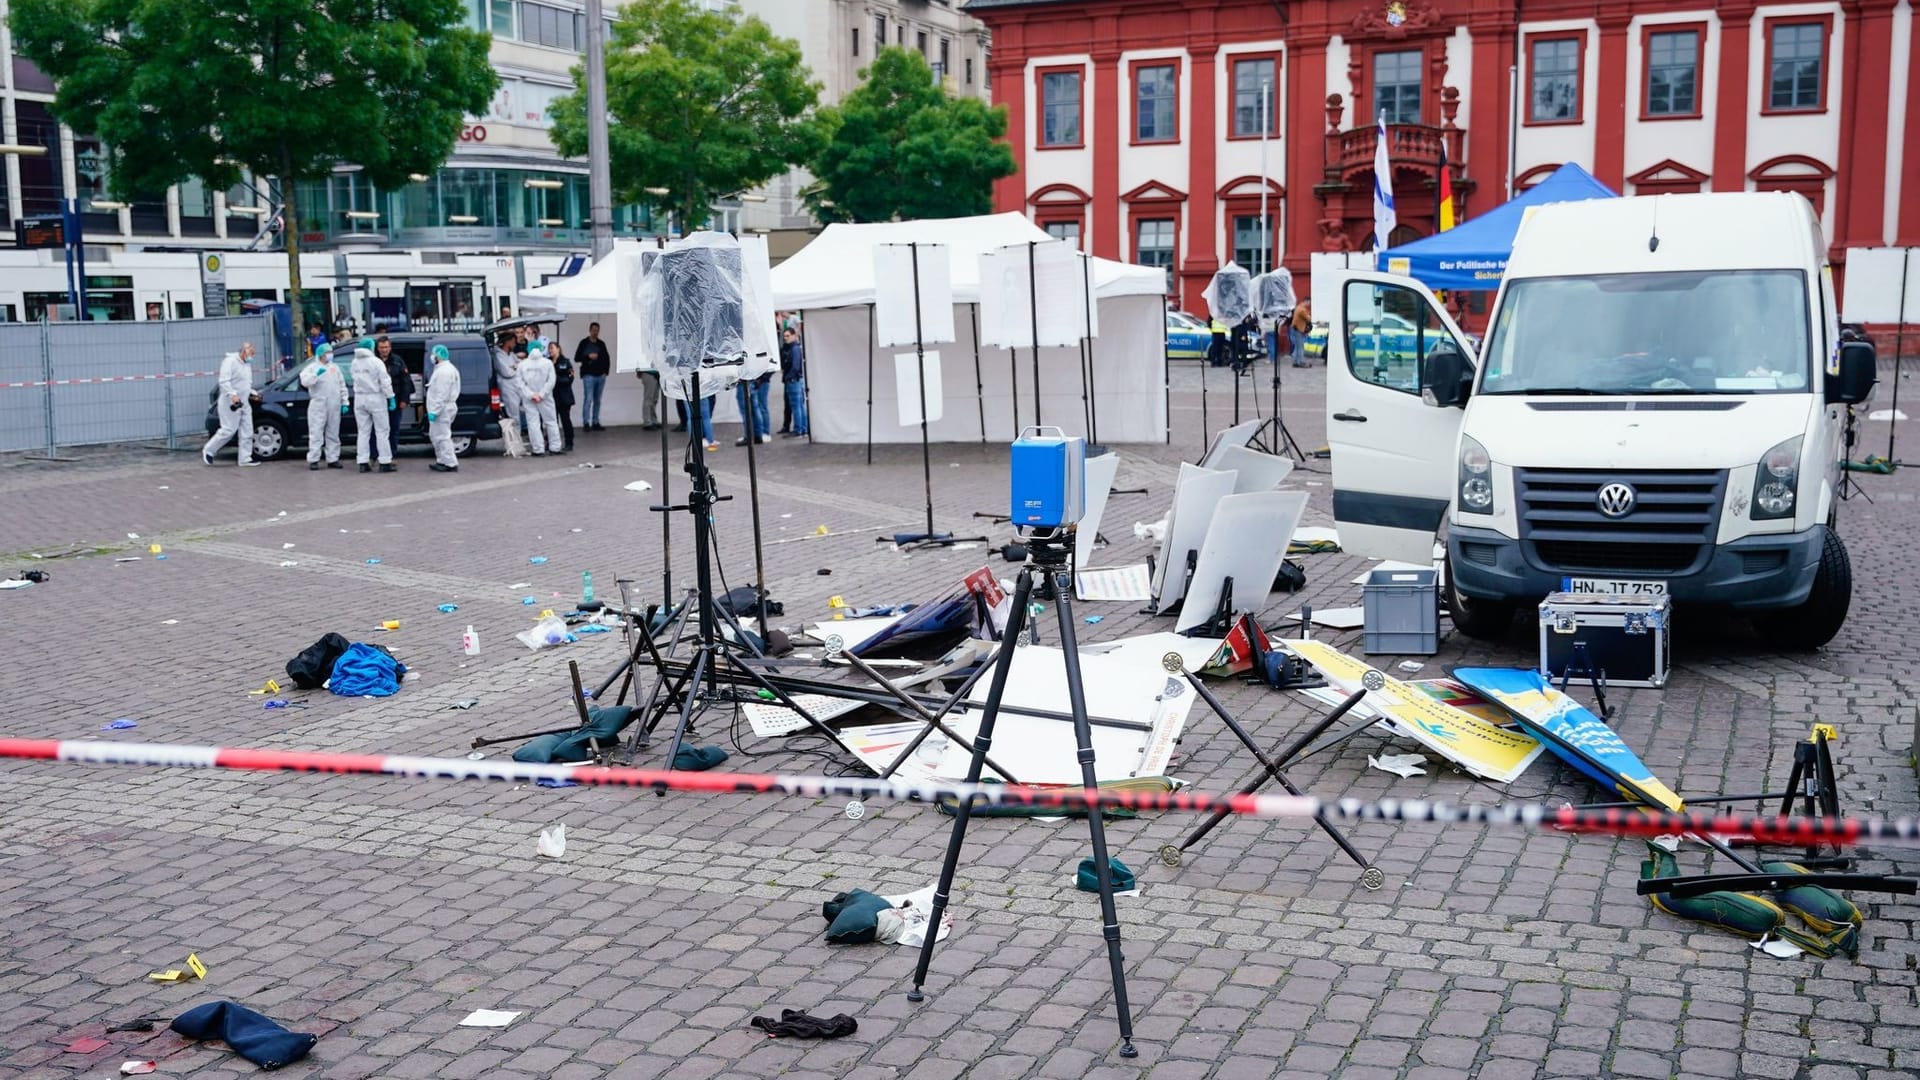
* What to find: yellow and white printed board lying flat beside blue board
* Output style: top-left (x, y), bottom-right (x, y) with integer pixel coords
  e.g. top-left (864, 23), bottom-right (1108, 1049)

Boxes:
top-left (1283, 642), bottom-right (1546, 784)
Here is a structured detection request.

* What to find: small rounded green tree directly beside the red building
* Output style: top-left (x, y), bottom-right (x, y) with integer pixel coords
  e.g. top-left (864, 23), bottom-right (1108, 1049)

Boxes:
top-left (806, 48), bottom-right (1014, 221)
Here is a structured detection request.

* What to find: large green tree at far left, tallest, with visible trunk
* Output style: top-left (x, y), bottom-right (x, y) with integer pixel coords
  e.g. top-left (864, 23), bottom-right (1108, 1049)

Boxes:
top-left (10, 0), bottom-right (499, 332)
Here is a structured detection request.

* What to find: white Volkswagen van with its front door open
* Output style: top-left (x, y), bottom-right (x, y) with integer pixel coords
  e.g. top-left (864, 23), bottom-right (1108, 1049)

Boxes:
top-left (1325, 192), bottom-right (1874, 648)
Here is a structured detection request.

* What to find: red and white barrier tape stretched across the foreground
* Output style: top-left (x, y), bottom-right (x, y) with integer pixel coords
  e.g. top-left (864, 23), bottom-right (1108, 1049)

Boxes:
top-left (0, 738), bottom-right (1920, 846)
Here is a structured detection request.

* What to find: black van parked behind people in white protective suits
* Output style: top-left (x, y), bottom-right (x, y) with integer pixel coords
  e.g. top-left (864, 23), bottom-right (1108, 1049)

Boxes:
top-left (207, 334), bottom-right (499, 461)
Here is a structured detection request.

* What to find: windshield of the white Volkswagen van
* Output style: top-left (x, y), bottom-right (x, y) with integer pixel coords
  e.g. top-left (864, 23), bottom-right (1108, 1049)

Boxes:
top-left (1480, 271), bottom-right (1812, 394)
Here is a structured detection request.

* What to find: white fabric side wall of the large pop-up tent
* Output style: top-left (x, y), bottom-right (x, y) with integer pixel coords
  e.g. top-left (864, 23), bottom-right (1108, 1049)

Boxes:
top-left (803, 294), bottom-right (1167, 444)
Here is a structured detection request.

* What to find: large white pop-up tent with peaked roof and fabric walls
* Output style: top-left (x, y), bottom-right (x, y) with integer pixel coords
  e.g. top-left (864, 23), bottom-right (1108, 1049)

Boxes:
top-left (772, 213), bottom-right (1167, 444)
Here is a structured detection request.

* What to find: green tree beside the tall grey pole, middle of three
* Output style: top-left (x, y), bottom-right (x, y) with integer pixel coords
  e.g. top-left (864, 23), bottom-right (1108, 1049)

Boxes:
top-left (549, 0), bottom-right (820, 225)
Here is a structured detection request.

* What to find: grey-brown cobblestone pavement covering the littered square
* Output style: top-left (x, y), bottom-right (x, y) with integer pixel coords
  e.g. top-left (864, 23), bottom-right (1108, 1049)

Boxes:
top-left (0, 367), bottom-right (1920, 1080)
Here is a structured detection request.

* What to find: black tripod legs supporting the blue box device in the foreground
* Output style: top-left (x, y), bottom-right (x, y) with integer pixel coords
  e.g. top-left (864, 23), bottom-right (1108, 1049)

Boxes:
top-left (906, 528), bottom-right (1140, 1057)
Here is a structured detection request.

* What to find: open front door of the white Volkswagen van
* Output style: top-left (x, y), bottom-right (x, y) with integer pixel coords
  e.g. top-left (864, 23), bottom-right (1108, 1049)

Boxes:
top-left (1327, 271), bottom-right (1475, 565)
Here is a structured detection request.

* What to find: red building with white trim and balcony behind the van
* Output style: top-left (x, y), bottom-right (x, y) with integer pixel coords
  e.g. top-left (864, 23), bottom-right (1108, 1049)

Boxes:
top-left (966, 0), bottom-right (1920, 309)
